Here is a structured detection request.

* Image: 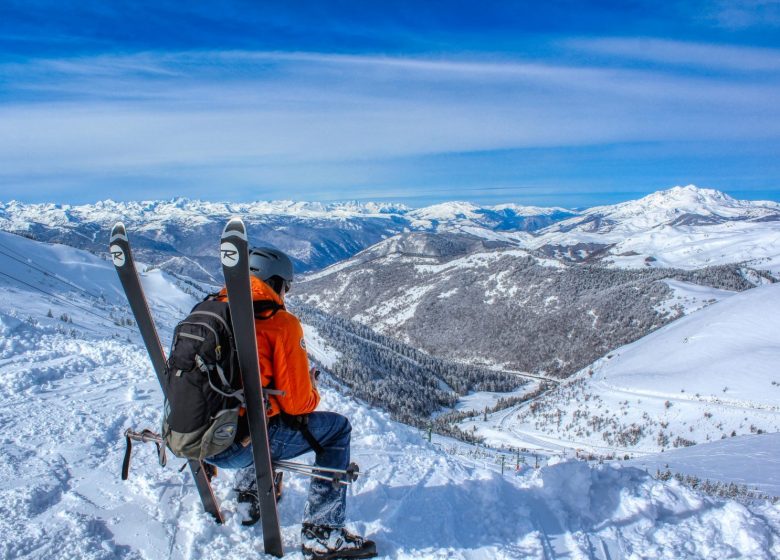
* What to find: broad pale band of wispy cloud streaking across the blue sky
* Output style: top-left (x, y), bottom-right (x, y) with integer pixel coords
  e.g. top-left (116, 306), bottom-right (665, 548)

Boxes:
top-left (0, 44), bottom-right (780, 198)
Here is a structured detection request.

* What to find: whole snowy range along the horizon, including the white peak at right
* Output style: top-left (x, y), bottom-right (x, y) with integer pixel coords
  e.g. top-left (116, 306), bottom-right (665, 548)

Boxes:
top-left (0, 185), bottom-right (780, 282)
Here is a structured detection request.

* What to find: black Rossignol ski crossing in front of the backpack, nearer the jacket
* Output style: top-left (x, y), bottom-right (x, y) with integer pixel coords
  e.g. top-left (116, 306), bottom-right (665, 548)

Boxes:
top-left (220, 218), bottom-right (284, 558)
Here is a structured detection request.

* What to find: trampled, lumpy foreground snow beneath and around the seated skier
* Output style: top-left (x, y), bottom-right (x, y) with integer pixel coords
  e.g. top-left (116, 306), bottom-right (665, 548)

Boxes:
top-left (0, 312), bottom-right (780, 559)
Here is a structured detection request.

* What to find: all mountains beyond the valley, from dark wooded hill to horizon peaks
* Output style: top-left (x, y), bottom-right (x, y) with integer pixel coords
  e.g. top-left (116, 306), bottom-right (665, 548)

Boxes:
top-left (0, 186), bottom-right (780, 376)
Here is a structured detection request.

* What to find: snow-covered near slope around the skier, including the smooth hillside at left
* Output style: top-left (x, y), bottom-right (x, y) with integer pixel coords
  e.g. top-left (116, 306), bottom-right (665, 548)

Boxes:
top-left (0, 221), bottom-right (780, 560)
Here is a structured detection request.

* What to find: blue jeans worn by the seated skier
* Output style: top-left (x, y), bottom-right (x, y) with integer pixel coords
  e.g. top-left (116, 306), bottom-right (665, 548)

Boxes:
top-left (206, 412), bottom-right (352, 527)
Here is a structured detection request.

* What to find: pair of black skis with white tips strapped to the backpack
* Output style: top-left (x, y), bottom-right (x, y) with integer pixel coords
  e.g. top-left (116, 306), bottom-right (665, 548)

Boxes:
top-left (109, 218), bottom-right (284, 557)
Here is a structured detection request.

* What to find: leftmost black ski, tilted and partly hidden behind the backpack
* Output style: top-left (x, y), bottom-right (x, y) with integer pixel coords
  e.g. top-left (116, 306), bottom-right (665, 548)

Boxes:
top-left (109, 222), bottom-right (223, 523)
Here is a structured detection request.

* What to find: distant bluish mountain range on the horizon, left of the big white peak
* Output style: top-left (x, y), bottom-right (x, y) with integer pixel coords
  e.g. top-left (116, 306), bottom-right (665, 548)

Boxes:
top-left (0, 198), bottom-right (574, 283)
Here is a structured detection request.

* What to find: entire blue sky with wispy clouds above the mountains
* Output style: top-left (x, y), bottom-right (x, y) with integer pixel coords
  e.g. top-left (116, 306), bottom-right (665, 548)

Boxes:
top-left (0, 0), bottom-right (780, 206)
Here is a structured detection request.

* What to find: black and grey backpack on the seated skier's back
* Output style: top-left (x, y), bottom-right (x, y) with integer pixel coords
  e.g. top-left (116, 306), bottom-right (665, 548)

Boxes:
top-left (162, 295), bottom-right (244, 460)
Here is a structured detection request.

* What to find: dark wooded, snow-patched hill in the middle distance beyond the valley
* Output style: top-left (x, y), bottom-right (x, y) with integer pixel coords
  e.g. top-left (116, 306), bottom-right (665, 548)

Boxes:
top-left (293, 228), bottom-right (762, 376)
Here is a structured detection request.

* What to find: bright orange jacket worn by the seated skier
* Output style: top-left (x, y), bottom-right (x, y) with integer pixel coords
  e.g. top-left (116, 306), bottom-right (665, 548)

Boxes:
top-left (219, 276), bottom-right (320, 417)
